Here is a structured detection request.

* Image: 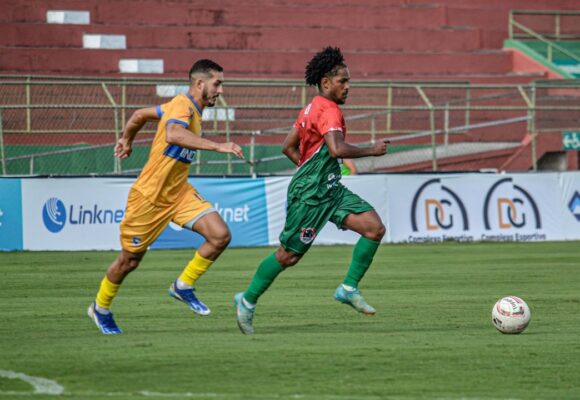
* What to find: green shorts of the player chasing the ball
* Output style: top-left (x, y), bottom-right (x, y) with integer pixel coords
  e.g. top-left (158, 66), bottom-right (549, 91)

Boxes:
top-left (280, 188), bottom-right (374, 255)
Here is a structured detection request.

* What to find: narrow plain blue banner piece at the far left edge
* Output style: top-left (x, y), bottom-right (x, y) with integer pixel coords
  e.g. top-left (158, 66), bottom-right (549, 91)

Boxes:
top-left (0, 179), bottom-right (22, 250)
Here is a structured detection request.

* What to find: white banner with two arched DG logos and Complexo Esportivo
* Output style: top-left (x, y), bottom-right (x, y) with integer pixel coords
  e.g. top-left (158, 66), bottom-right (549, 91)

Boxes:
top-left (387, 173), bottom-right (566, 243)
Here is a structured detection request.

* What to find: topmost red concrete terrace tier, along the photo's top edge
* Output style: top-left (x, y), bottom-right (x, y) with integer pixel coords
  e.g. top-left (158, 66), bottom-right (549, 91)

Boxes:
top-left (0, 0), bottom-right (445, 29)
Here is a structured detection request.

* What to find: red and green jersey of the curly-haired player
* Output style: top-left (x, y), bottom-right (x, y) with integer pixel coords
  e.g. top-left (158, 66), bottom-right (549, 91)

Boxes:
top-left (288, 96), bottom-right (346, 204)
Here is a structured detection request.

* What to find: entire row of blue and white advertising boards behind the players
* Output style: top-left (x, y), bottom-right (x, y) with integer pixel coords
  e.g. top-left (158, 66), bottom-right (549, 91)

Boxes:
top-left (0, 172), bottom-right (580, 251)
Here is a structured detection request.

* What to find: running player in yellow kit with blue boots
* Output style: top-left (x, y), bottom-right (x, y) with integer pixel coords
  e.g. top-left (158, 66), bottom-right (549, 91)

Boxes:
top-left (88, 60), bottom-right (243, 334)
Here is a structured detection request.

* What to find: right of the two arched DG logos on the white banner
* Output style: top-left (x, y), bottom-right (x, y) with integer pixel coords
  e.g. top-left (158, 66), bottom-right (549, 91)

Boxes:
top-left (483, 178), bottom-right (542, 230)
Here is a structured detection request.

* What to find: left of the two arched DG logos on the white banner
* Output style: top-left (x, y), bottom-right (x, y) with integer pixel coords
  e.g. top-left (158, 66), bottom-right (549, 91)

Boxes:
top-left (411, 179), bottom-right (469, 232)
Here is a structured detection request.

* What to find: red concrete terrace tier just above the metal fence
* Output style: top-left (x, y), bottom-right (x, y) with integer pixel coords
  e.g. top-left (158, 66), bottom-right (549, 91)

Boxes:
top-left (0, 47), bottom-right (512, 79)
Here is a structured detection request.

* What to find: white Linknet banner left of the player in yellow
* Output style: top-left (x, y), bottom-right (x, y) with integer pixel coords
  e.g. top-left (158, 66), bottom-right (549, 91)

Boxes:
top-left (22, 178), bottom-right (134, 250)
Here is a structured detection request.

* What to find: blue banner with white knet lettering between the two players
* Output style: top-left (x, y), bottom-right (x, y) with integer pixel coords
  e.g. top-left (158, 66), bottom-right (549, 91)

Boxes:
top-left (151, 178), bottom-right (268, 249)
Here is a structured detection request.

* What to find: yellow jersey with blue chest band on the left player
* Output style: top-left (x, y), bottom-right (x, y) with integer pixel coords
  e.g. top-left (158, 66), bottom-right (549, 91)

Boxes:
top-left (133, 93), bottom-right (202, 206)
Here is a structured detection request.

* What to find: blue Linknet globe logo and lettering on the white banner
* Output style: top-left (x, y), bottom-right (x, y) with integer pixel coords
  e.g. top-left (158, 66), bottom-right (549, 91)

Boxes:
top-left (42, 197), bottom-right (125, 233)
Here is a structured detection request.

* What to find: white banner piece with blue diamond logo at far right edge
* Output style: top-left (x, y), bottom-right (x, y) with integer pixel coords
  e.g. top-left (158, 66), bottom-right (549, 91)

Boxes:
top-left (559, 172), bottom-right (580, 240)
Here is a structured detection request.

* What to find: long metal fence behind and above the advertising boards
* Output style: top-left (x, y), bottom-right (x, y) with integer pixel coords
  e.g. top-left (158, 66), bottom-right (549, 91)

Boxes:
top-left (0, 76), bottom-right (580, 175)
